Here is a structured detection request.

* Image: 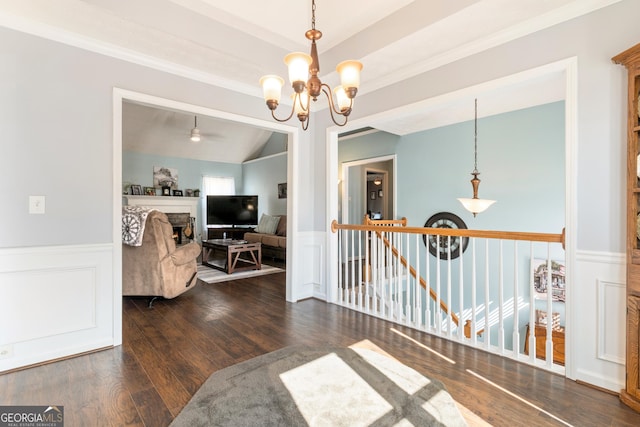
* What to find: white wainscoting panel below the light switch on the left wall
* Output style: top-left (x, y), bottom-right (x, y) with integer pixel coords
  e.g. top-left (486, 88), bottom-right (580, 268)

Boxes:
top-left (0, 244), bottom-right (114, 372)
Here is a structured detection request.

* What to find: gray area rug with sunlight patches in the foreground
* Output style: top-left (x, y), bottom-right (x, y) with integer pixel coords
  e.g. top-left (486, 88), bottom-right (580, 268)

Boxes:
top-left (171, 347), bottom-right (467, 427)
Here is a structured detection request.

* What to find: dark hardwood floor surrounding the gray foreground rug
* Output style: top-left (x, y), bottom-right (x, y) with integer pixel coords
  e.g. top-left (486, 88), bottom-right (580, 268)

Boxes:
top-left (0, 273), bottom-right (640, 427)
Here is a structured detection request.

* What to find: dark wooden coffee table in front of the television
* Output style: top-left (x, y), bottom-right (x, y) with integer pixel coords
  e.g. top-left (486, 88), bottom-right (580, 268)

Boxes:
top-left (202, 239), bottom-right (262, 274)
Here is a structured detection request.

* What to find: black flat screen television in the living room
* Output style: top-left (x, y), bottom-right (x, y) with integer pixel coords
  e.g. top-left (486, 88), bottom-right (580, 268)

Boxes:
top-left (207, 196), bottom-right (258, 226)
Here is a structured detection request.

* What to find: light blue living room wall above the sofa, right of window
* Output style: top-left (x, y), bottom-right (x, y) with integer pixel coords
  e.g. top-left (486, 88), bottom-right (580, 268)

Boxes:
top-left (242, 153), bottom-right (287, 215)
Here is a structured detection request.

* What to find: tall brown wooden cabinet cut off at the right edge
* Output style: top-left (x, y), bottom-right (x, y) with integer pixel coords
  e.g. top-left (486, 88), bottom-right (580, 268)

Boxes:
top-left (613, 44), bottom-right (640, 411)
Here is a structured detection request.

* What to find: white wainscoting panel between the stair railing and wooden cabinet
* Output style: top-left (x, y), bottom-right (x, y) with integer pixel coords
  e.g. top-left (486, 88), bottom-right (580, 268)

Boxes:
top-left (567, 251), bottom-right (626, 392)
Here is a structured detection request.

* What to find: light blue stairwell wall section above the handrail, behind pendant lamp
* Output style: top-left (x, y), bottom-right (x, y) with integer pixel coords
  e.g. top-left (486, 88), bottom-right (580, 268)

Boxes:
top-left (397, 102), bottom-right (565, 233)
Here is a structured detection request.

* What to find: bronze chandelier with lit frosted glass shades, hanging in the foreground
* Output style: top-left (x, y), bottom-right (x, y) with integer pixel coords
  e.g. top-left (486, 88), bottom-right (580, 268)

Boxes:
top-left (260, 0), bottom-right (362, 130)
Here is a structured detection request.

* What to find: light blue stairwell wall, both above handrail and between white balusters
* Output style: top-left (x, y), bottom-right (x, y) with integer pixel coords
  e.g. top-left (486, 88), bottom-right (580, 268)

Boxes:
top-left (339, 102), bottom-right (565, 347)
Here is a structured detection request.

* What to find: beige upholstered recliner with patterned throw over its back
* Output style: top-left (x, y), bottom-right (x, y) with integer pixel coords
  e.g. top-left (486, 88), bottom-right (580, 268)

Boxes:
top-left (122, 207), bottom-right (201, 306)
